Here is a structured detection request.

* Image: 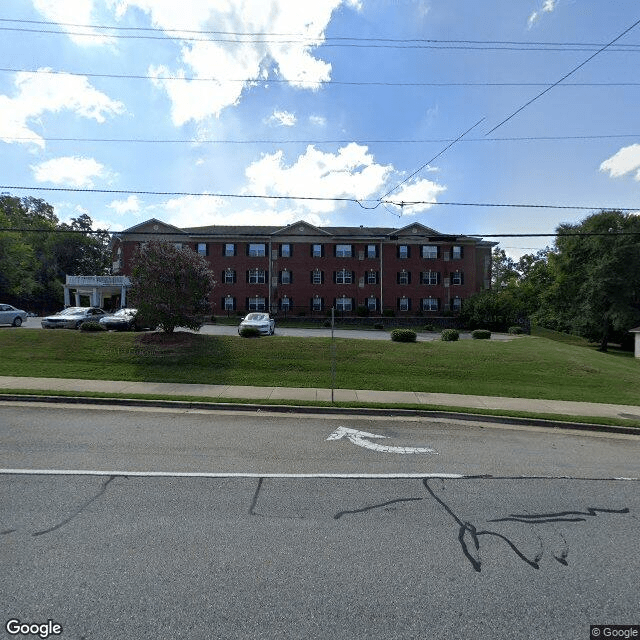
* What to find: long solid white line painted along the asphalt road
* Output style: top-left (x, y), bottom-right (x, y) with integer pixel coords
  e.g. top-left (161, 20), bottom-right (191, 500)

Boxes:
top-left (0, 469), bottom-right (640, 482)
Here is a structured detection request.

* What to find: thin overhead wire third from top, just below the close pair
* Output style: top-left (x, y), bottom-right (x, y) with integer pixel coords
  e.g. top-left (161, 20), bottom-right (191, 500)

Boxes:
top-left (5, 67), bottom-right (640, 87)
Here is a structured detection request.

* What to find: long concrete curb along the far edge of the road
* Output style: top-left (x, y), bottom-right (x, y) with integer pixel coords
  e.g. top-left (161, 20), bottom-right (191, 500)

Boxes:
top-left (0, 394), bottom-right (640, 436)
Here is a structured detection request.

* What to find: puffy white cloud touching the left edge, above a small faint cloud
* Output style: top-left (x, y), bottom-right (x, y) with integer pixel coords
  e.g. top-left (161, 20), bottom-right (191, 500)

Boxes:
top-left (0, 69), bottom-right (124, 147)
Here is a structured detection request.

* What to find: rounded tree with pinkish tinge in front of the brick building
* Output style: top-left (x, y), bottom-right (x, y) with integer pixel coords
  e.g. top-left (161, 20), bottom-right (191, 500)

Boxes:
top-left (129, 241), bottom-right (215, 333)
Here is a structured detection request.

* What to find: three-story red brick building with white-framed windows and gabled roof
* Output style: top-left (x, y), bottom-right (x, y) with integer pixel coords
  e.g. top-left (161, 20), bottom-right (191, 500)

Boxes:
top-left (112, 219), bottom-right (496, 316)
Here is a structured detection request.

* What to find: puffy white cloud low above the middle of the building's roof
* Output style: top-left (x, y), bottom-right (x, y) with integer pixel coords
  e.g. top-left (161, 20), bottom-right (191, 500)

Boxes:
top-left (245, 143), bottom-right (393, 213)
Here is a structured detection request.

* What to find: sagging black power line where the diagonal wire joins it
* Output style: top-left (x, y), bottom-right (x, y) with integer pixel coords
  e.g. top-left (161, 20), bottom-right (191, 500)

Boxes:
top-left (0, 185), bottom-right (638, 212)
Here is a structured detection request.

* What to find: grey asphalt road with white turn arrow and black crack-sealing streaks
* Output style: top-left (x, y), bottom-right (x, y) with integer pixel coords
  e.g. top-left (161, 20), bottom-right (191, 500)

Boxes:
top-left (0, 403), bottom-right (640, 640)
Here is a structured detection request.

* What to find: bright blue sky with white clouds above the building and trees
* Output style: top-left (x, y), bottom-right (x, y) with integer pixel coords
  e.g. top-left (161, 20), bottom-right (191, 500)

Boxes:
top-left (0, 0), bottom-right (640, 257)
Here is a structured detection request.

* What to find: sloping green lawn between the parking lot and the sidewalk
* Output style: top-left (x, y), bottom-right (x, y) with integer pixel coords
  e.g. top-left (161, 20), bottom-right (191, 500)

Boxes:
top-left (0, 328), bottom-right (640, 405)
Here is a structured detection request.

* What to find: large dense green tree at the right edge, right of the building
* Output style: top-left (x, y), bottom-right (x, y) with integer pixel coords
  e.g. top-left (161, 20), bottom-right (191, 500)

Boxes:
top-left (542, 211), bottom-right (640, 351)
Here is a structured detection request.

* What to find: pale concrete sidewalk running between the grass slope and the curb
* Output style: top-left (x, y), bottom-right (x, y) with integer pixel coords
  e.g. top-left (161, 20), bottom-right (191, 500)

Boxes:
top-left (0, 376), bottom-right (640, 420)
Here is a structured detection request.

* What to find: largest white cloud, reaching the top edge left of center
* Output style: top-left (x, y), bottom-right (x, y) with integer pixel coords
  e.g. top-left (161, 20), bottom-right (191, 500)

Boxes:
top-left (110, 0), bottom-right (361, 126)
